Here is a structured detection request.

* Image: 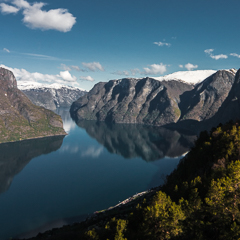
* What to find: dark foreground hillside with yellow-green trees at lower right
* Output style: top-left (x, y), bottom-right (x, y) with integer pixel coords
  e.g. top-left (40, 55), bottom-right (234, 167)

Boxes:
top-left (78, 123), bottom-right (240, 240)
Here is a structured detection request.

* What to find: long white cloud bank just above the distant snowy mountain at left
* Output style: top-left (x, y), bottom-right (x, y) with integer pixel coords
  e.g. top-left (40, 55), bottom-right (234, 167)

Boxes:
top-left (0, 64), bottom-right (78, 85)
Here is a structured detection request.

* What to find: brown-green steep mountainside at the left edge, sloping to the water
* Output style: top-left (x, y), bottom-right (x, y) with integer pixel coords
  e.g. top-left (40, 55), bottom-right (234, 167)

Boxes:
top-left (0, 68), bottom-right (66, 143)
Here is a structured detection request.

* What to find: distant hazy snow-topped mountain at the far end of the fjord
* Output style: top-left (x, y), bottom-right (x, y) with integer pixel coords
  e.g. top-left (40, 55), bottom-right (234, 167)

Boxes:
top-left (17, 81), bottom-right (86, 110)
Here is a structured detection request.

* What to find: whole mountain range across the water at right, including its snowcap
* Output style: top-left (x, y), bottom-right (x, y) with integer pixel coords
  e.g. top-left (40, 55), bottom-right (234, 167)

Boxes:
top-left (70, 69), bottom-right (240, 131)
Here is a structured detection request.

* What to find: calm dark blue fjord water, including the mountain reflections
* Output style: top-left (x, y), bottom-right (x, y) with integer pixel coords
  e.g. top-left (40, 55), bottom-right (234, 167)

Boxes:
top-left (0, 110), bottom-right (195, 240)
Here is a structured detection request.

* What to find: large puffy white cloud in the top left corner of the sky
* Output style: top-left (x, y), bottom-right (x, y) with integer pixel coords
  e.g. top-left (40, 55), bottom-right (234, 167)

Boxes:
top-left (1, 0), bottom-right (76, 32)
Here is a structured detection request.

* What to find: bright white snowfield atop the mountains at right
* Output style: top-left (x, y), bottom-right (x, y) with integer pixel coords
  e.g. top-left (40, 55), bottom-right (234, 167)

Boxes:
top-left (154, 69), bottom-right (218, 84)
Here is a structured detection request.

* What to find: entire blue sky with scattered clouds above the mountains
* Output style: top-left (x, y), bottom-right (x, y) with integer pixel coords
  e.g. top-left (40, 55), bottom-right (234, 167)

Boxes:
top-left (0, 0), bottom-right (240, 90)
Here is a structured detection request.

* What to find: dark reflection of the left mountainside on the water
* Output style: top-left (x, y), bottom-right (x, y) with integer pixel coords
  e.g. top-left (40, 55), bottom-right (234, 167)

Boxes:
top-left (0, 136), bottom-right (64, 193)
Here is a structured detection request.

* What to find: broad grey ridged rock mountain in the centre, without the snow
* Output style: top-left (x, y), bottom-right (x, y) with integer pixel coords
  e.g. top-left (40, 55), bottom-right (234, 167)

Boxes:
top-left (70, 78), bottom-right (193, 125)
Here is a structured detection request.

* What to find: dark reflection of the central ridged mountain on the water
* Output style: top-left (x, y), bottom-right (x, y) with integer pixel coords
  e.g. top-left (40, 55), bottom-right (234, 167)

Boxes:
top-left (78, 121), bottom-right (196, 161)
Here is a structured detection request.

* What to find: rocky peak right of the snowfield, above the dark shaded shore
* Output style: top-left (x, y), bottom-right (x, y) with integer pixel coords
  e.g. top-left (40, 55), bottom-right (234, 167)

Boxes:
top-left (180, 70), bottom-right (235, 121)
